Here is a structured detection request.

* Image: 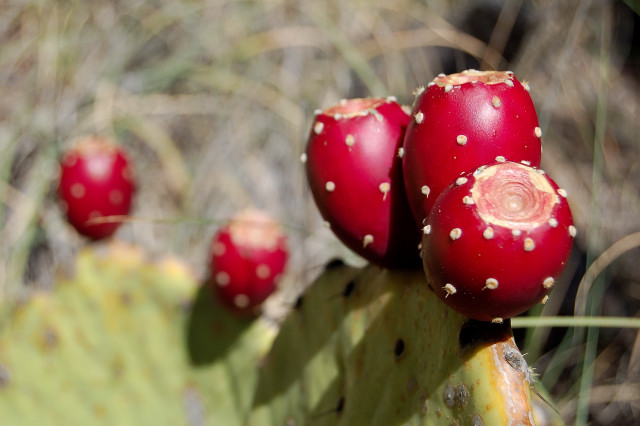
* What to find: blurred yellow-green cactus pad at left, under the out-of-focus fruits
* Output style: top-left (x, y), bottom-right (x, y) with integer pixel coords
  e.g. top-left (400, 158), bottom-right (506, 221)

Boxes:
top-left (0, 244), bottom-right (273, 425)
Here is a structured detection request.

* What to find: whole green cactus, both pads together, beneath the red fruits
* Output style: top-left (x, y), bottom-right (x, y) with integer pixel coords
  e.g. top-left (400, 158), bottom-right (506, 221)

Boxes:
top-left (0, 243), bottom-right (548, 426)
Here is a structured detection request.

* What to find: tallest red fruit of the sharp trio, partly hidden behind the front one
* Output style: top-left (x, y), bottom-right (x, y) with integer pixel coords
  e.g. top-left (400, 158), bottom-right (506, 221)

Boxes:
top-left (402, 70), bottom-right (542, 224)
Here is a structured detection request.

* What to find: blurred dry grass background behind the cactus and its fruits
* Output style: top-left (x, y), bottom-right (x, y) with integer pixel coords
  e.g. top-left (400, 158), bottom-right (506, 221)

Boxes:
top-left (0, 0), bottom-right (640, 424)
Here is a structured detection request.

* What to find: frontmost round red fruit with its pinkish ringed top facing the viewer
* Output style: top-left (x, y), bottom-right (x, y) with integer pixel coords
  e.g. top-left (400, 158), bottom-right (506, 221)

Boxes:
top-left (422, 162), bottom-right (576, 322)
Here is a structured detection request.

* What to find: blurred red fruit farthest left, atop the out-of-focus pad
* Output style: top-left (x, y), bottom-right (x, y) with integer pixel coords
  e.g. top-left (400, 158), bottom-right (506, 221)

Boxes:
top-left (58, 137), bottom-right (136, 240)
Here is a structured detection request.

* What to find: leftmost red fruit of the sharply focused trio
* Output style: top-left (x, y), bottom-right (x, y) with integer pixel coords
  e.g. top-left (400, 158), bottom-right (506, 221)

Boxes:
top-left (304, 97), bottom-right (420, 267)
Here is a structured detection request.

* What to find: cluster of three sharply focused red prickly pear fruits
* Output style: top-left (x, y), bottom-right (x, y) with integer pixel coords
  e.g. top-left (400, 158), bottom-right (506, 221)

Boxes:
top-left (303, 70), bottom-right (576, 322)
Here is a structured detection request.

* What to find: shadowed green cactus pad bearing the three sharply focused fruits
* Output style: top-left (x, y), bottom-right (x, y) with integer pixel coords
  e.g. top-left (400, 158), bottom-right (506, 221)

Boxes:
top-left (249, 265), bottom-right (534, 426)
